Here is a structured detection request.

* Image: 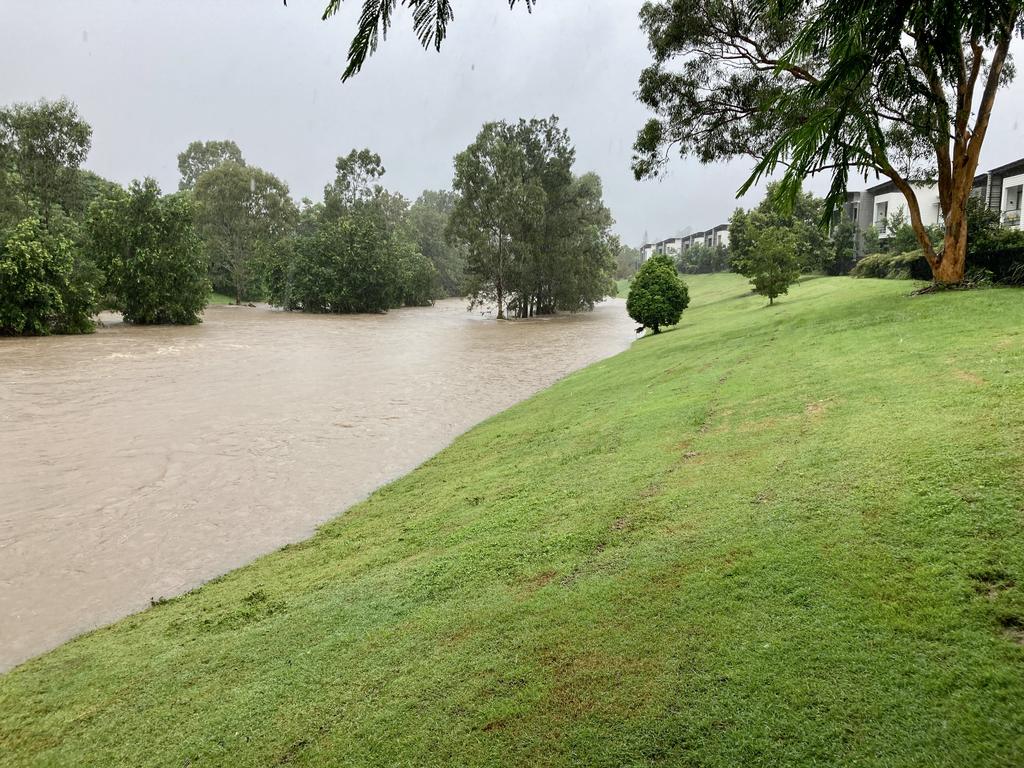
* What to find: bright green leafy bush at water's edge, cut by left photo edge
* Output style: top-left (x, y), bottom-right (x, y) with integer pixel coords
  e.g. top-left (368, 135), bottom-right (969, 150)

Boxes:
top-left (0, 217), bottom-right (100, 336)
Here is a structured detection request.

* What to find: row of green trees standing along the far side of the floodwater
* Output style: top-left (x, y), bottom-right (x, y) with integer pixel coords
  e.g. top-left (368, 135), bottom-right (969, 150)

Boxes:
top-left (0, 99), bottom-right (621, 334)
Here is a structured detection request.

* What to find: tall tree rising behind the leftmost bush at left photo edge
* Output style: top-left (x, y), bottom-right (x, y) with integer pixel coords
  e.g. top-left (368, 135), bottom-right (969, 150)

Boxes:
top-left (0, 98), bottom-right (92, 219)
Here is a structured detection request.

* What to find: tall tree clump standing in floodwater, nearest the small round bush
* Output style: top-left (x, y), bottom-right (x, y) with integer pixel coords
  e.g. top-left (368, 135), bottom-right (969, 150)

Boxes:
top-left (449, 117), bottom-right (615, 318)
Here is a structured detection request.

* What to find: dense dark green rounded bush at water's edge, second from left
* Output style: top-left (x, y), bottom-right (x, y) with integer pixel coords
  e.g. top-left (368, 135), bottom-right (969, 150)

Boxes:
top-left (87, 178), bottom-right (210, 325)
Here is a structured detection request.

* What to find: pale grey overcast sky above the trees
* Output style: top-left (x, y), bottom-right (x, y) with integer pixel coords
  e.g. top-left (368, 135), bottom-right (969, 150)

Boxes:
top-left (0, 0), bottom-right (1024, 245)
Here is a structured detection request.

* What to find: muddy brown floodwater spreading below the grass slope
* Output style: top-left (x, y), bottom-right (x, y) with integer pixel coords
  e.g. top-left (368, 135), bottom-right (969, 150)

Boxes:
top-left (0, 300), bottom-right (634, 670)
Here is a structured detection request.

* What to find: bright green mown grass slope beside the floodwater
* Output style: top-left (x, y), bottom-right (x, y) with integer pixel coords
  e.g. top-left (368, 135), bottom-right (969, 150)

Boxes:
top-left (0, 275), bottom-right (1024, 767)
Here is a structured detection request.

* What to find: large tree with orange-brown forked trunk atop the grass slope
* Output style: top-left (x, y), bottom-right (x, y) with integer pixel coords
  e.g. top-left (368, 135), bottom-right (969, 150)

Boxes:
top-left (634, 0), bottom-right (1022, 283)
